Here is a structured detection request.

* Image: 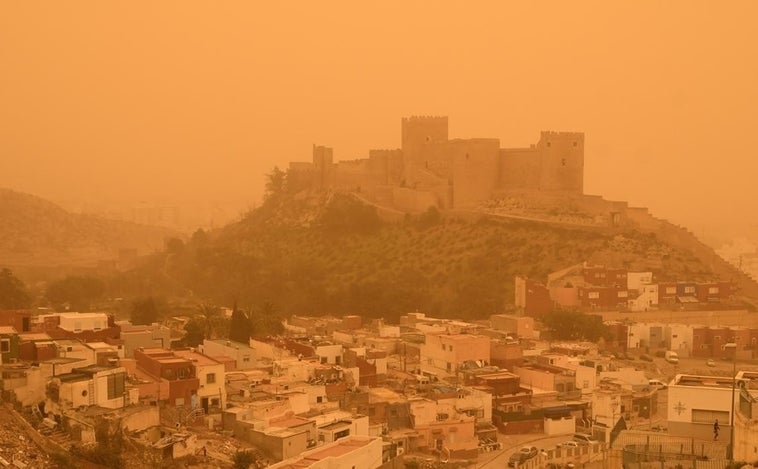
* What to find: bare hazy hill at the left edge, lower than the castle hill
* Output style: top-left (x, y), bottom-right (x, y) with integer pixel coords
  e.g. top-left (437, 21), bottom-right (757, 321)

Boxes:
top-left (0, 188), bottom-right (176, 266)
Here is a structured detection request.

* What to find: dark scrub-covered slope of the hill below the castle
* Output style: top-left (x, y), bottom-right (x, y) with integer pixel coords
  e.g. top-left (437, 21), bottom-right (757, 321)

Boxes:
top-left (110, 187), bottom-right (713, 320)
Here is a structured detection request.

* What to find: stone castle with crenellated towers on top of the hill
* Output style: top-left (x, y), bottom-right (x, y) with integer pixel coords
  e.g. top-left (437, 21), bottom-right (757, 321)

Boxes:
top-left (288, 116), bottom-right (584, 213)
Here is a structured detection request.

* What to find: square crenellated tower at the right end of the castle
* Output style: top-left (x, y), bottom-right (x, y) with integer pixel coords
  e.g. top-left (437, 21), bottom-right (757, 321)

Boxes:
top-left (537, 132), bottom-right (584, 194)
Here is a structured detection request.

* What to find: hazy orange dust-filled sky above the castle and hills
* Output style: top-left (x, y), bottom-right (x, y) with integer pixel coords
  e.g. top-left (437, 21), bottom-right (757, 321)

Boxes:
top-left (0, 0), bottom-right (758, 238)
